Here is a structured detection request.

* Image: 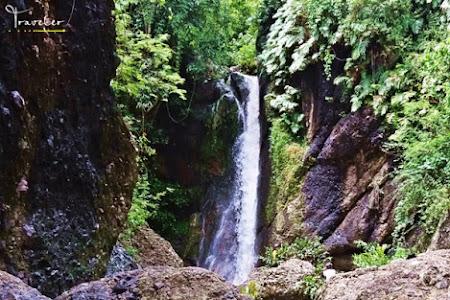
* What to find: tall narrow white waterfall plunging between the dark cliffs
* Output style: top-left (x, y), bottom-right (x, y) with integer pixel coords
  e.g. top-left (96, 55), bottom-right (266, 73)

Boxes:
top-left (200, 76), bottom-right (261, 284)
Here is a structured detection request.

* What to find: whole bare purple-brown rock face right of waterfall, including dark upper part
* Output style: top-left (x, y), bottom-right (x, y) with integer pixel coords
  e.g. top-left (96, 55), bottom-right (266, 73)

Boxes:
top-left (268, 61), bottom-right (396, 268)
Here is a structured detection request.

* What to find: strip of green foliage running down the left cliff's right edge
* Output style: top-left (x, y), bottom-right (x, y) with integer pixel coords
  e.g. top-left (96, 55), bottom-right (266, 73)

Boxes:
top-left (111, 0), bottom-right (189, 244)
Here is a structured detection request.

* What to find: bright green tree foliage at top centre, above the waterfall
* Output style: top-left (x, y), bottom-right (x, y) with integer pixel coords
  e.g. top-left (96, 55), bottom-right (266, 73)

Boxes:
top-left (126, 0), bottom-right (260, 79)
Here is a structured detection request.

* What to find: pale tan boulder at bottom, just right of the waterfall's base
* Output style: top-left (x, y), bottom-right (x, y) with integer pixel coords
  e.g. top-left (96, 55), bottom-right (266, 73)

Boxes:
top-left (243, 259), bottom-right (314, 300)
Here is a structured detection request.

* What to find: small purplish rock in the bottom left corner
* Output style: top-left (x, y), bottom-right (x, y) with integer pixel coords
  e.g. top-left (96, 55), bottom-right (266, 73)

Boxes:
top-left (0, 271), bottom-right (50, 300)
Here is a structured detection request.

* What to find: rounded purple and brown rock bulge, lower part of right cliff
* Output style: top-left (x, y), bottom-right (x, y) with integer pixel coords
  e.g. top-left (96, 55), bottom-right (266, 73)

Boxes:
top-left (303, 108), bottom-right (392, 248)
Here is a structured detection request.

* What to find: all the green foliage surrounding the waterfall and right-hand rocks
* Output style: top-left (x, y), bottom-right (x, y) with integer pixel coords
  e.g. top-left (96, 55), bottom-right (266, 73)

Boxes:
top-left (112, 0), bottom-right (450, 274)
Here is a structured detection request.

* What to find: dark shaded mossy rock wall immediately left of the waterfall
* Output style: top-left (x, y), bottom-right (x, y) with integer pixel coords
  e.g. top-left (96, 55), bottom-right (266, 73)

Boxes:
top-left (149, 80), bottom-right (243, 255)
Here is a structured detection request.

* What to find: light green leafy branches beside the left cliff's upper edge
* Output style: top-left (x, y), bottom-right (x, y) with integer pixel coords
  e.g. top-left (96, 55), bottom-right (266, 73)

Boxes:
top-left (112, 0), bottom-right (186, 134)
